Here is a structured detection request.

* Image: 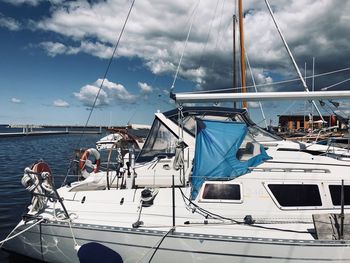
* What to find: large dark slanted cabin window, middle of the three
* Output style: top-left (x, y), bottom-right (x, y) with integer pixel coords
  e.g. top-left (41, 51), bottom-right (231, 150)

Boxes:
top-left (269, 184), bottom-right (322, 207)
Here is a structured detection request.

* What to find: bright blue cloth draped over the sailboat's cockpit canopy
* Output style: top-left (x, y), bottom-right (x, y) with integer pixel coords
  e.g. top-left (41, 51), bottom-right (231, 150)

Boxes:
top-left (191, 120), bottom-right (270, 199)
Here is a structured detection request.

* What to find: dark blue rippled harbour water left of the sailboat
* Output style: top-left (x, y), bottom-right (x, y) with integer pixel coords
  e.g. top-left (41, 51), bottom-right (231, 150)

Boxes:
top-left (0, 133), bottom-right (102, 263)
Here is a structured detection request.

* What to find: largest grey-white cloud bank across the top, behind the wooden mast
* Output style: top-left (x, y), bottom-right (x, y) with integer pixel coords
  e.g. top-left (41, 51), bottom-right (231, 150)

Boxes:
top-left (23, 0), bottom-right (350, 93)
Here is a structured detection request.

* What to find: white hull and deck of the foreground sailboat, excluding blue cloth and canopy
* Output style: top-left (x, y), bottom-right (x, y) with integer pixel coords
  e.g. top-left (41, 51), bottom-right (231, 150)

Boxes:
top-left (4, 108), bottom-right (350, 263)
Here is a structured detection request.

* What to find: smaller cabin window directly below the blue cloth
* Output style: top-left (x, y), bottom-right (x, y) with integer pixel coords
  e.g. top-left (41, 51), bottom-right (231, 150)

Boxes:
top-left (202, 184), bottom-right (241, 200)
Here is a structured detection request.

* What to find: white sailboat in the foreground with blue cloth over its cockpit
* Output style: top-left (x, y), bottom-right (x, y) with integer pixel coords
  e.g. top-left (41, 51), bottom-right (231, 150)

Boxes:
top-left (2, 0), bottom-right (350, 263)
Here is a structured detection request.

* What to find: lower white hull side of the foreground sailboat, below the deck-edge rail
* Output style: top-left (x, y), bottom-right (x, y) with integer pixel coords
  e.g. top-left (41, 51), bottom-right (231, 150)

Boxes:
top-left (5, 223), bottom-right (350, 263)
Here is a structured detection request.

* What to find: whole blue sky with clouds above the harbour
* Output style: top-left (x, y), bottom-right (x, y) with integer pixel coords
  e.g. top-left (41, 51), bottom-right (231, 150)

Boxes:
top-left (0, 0), bottom-right (350, 128)
